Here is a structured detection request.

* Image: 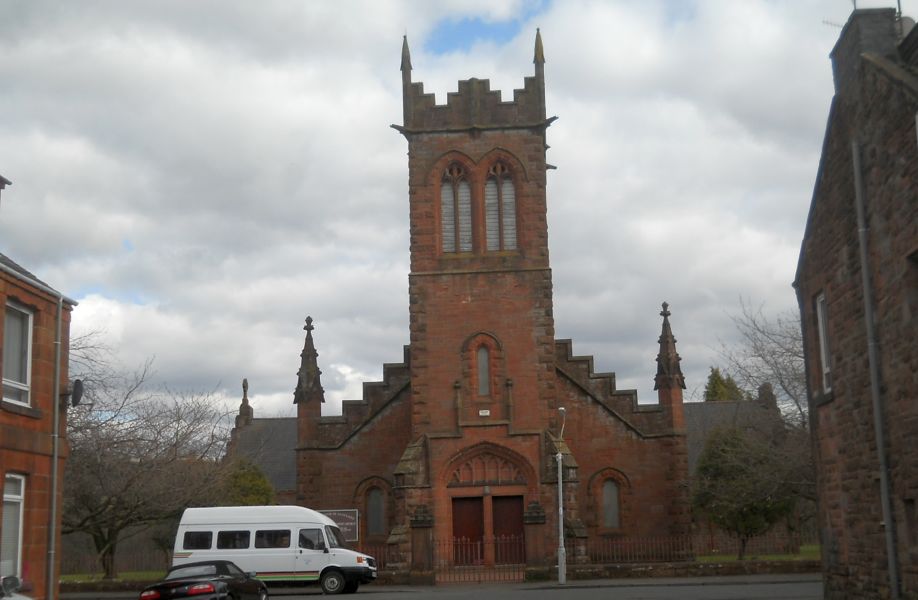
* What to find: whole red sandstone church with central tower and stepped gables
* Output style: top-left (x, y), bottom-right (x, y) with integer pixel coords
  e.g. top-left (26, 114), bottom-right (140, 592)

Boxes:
top-left (232, 33), bottom-right (690, 570)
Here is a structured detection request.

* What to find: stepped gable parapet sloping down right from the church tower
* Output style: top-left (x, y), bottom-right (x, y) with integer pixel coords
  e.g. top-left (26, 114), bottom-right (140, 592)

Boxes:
top-left (555, 339), bottom-right (667, 437)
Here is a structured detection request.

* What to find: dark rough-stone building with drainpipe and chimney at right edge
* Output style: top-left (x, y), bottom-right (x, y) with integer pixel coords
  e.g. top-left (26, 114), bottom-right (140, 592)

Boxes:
top-left (794, 9), bottom-right (918, 598)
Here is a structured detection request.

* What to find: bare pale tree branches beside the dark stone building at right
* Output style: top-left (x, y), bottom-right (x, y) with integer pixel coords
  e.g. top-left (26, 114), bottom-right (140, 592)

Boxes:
top-left (720, 299), bottom-right (808, 428)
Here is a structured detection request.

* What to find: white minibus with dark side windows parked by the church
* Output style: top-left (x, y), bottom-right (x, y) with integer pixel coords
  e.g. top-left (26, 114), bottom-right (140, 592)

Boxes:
top-left (172, 506), bottom-right (376, 594)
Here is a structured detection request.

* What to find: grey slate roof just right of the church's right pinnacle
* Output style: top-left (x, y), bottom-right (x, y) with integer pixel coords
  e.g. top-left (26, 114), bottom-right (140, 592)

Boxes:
top-left (683, 400), bottom-right (782, 475)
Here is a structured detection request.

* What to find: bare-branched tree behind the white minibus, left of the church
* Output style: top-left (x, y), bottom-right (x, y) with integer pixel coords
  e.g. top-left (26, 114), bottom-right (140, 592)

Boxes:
top-left (62, 337), bottom-right (228, 578)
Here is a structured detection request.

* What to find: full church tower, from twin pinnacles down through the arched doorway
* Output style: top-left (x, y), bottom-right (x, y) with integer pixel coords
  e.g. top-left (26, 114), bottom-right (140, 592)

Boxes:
top-left (394, 32), bottom-right (558, 562)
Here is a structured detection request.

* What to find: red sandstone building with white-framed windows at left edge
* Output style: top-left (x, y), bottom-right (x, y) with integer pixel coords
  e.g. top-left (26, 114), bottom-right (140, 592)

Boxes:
top-left (0, 177), bottom-right (76, 599)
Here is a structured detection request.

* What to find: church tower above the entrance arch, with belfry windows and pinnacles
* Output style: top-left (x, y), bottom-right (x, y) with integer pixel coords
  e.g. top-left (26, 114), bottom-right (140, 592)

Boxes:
top-left (395, 32), bottom-right (554, 434)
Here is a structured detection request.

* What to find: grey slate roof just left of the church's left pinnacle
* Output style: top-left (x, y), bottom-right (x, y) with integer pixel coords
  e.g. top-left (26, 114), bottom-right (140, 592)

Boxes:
top-left (235, 417), bottom-right (296, 492)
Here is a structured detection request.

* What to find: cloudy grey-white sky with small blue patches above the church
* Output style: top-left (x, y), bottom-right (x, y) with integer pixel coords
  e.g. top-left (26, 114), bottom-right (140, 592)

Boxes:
top-left (0, 0), bottom-right (918, 417)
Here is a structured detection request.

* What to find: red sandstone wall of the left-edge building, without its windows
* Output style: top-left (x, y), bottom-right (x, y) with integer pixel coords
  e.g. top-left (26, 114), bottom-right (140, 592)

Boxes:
top-left (0, 273), bottom-right (70, 599)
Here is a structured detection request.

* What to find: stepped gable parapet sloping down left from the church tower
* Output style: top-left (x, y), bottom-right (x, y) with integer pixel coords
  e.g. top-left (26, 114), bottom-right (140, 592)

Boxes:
top-left (318, 346), bottom-right (411, 447)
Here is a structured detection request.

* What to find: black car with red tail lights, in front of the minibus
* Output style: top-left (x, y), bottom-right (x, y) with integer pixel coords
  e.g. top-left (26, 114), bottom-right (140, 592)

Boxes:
top-left (140, 560), bottom-right (268, 600)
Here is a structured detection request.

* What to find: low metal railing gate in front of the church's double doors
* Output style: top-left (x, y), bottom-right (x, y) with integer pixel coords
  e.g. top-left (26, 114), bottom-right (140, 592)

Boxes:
top-left (433, 535), bottom-right (526, 583)
